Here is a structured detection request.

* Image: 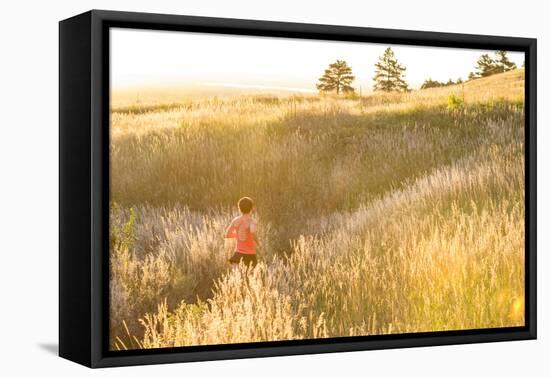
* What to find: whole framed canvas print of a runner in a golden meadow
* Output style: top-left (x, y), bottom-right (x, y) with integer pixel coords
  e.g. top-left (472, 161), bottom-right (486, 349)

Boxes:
top-left (59, 10), bottom-right (536, 367)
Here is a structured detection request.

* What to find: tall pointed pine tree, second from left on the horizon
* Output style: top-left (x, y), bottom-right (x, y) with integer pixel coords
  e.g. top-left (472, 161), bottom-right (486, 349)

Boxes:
top-left (373, 47), bottom-right (409, 92)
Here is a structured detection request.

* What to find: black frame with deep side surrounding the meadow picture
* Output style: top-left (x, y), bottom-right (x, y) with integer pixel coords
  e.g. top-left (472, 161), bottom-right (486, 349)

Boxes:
top-left (59, 10), bottom-right (537, 368)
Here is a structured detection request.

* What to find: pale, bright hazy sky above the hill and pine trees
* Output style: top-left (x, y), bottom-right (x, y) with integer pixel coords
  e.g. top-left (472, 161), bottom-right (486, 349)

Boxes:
top-left (111, 28), bottom-right (524, 92)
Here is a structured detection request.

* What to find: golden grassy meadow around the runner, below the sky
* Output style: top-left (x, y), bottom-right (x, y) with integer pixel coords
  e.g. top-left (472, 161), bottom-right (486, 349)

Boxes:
top-left (110, 69), bottom-right (525, 349)
